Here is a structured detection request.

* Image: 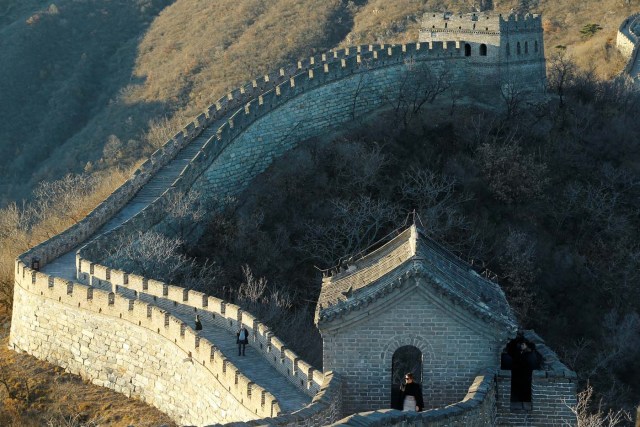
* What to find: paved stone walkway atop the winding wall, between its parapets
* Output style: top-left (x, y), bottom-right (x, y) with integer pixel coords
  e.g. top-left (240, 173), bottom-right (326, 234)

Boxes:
top-left (42, 119), bottom-right (311, 413)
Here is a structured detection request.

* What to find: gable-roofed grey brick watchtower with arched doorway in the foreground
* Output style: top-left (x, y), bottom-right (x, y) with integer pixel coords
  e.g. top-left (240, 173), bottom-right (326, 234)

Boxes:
top-left (315, 225), bottom-right (575, 425)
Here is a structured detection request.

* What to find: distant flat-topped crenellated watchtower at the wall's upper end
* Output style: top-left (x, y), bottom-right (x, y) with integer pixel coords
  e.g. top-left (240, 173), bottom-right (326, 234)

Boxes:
top-left (419, 12), bottom-right (546, 88)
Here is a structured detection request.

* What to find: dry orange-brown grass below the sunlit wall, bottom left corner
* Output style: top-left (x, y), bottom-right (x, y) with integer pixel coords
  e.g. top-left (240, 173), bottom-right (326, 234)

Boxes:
top-left (0, 313), bottom-right (175, 427)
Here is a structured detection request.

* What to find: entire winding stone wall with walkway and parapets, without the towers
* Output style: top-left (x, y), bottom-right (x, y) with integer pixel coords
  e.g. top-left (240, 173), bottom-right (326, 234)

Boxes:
top-left (10, 11), bottom-right (637, 426)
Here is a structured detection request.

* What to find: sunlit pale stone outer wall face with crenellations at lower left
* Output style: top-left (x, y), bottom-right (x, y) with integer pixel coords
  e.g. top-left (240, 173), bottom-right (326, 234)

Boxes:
top-left (10, 263), bottom-right (280, 425)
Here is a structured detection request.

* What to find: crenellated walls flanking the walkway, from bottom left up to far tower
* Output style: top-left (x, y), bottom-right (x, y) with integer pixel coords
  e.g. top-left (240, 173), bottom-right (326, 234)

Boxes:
top-left (10, 38), bottom-right (556, 425)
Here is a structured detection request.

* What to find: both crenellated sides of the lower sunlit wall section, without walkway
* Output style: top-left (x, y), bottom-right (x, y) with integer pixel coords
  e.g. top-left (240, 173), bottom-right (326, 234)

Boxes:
top-left (10, 261), bottom-right (342, 426)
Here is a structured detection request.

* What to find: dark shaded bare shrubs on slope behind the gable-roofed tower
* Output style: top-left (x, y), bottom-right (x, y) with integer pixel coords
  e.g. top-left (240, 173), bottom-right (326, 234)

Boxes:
top-left (168, 66), bottom-right (640, 411)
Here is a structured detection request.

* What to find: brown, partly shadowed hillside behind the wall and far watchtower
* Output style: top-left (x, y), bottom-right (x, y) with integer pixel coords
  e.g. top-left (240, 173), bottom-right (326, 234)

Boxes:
top-left (0, 0), bottom-right (638, 206)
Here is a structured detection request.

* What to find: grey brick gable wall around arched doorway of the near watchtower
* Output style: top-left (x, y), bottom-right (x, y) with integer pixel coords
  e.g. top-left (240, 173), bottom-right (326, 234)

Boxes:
top-left (320, 270), bottom-right (507, 414)
